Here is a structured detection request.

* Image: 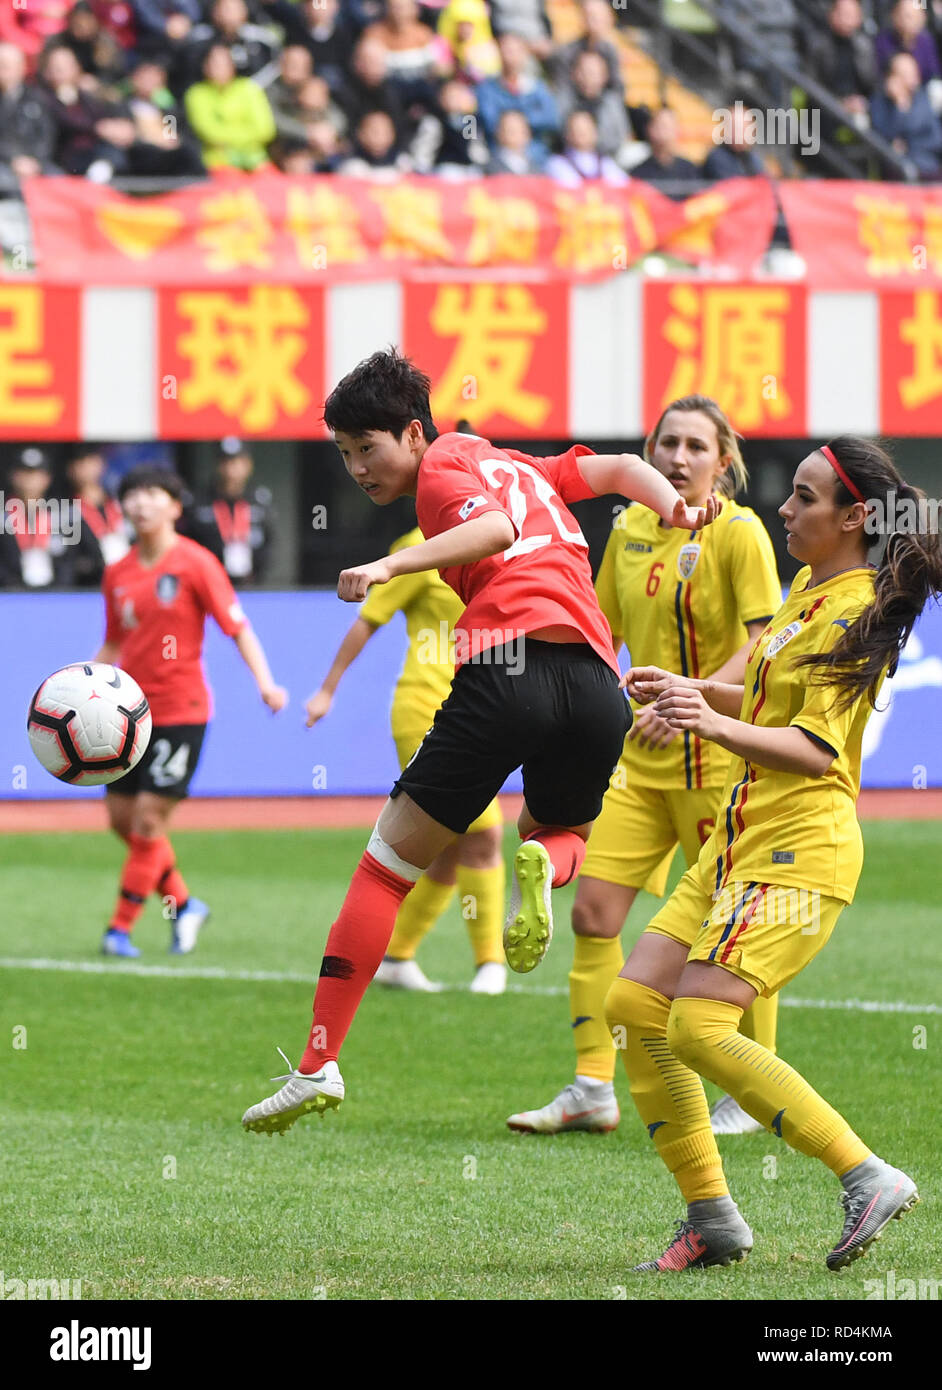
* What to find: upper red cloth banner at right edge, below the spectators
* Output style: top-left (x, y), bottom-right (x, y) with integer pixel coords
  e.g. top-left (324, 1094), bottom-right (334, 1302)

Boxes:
top-left (778, 182), bottom-right (942, 289)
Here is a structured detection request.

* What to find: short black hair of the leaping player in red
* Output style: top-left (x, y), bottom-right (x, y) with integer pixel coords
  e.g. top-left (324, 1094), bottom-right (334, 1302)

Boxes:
top-left (324, 348), bottom-right (438, 443)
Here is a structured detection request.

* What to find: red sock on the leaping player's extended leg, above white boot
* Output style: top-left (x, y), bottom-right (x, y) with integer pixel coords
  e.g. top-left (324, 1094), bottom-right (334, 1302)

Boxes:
top-left (297, 852), bottom-right (418, 1076)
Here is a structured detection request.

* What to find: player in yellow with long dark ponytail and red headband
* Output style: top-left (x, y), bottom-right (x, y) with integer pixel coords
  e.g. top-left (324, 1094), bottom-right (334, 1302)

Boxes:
top-left (606, 435), bottom-right (942, 1270)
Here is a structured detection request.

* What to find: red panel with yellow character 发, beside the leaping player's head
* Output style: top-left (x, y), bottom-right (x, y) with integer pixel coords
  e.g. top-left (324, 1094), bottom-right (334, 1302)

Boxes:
top-left (403, 281), bottom-right (570, 439)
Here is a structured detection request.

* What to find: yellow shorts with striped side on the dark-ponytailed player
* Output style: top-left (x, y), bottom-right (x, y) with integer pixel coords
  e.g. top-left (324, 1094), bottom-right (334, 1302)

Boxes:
top-left (645, 865), bottom-right (846, 998)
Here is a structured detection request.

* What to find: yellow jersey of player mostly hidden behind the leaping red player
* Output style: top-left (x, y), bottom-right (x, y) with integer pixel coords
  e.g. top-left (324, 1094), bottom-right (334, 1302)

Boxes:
top-left (360, 527), bottom-right (464, 724)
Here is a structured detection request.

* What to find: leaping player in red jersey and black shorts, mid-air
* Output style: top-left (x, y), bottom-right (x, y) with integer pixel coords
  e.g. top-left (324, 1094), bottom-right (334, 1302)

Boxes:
top-left (243, 349), bottom-right (717, 1133)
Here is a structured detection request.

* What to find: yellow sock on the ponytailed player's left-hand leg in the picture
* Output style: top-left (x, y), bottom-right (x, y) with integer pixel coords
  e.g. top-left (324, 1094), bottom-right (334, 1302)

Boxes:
top-left (606, 976), bottom-right (729, 1202)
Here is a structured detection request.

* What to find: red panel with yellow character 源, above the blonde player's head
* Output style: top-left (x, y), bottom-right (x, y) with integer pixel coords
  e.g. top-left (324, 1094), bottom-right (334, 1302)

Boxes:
top-left (643, 281), bottom-right (807, 436)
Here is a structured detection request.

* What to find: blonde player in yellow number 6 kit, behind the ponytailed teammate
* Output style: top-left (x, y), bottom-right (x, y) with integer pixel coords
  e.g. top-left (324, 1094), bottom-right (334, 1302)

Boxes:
top-left (507, 396), bottom-right (782, 1134)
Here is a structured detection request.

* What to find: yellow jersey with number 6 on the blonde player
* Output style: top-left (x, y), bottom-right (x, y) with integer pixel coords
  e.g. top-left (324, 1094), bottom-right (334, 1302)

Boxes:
top-left (596, 499), bottom-right (782, 790)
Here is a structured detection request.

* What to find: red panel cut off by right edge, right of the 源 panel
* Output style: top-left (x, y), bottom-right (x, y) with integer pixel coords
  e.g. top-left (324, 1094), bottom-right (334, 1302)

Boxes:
top-left (879, 289), bottom-right (942, 435)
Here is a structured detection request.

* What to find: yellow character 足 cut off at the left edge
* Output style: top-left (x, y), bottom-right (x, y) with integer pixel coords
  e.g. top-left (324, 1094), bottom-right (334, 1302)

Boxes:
top-left (0, 285), bottom-right (65, 427)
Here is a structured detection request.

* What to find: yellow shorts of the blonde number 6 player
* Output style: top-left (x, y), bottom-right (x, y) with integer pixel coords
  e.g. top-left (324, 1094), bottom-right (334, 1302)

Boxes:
top-left (582, 762), bottom-right (722, 898)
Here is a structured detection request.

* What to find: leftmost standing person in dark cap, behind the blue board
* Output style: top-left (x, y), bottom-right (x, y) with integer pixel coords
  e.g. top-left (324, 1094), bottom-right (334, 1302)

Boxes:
top-left (0, 448), bottom-right (72, 589)
